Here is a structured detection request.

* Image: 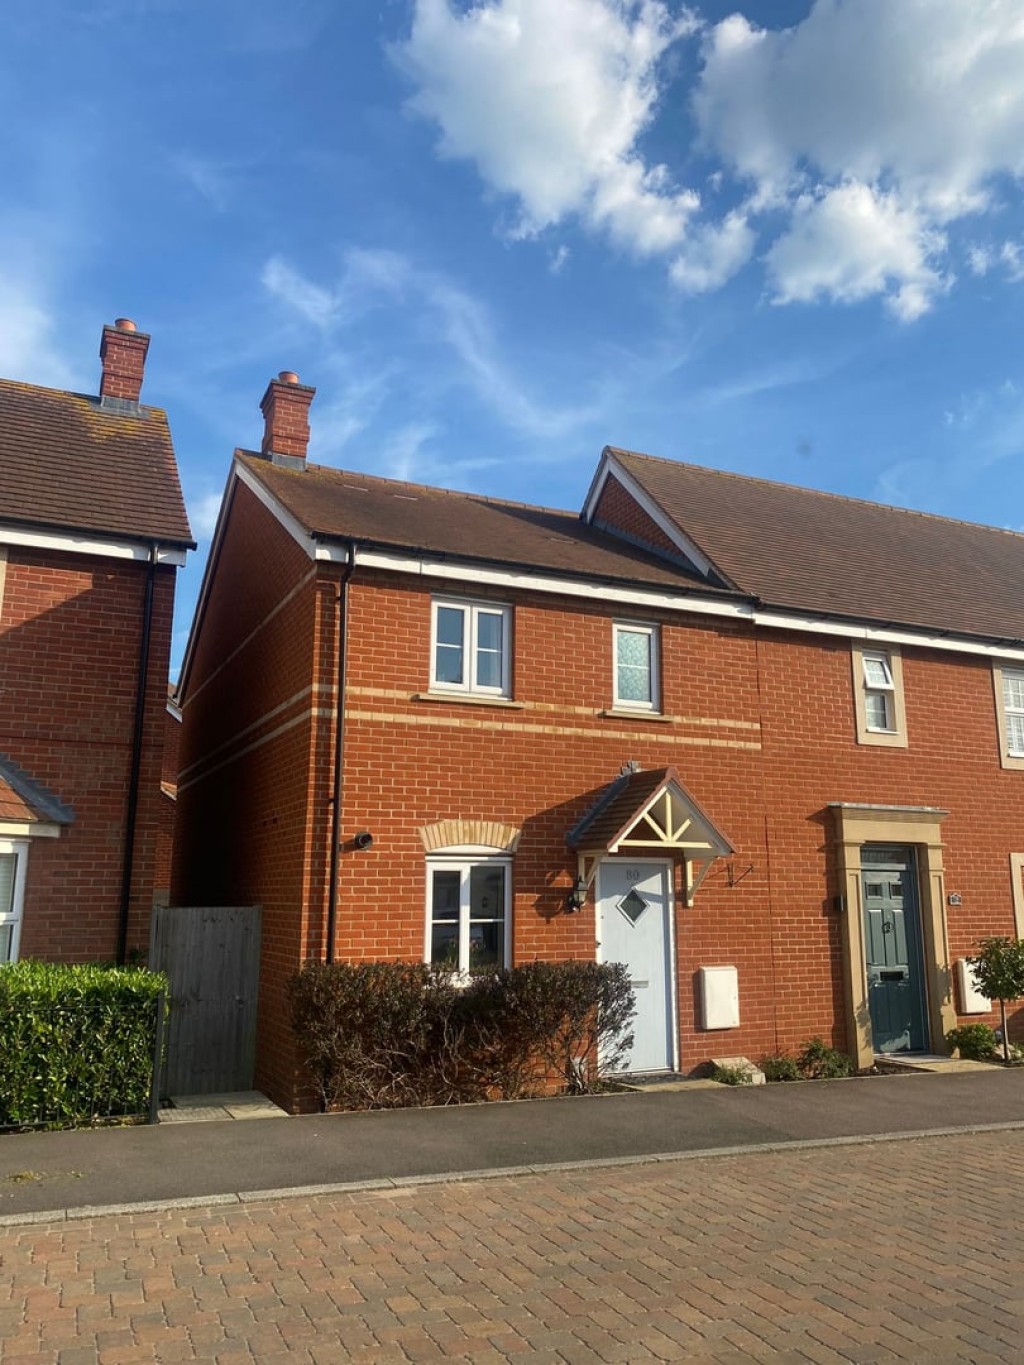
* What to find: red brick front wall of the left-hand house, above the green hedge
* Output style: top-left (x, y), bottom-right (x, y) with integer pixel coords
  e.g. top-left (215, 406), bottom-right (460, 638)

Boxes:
top-left (0, 550), bottom-right (175, 961)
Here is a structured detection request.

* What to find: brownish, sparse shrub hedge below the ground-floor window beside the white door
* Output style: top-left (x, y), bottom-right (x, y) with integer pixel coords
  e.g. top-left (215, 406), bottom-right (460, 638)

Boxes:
top-left (291, 962), bottom-right (634, 1110)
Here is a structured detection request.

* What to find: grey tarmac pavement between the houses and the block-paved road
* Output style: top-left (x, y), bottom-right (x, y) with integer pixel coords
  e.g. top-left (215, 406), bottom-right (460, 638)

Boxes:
top-left (0, 1067), bottom-right (1024, 1222)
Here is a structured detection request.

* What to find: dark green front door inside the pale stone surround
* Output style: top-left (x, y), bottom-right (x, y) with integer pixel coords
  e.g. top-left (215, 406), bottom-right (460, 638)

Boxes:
top-left (860, 845), bottom-right (927, 1052)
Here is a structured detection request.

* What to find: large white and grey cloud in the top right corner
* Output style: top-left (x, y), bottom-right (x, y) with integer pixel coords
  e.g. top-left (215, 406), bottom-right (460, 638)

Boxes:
top-left (694, 0), bottom-right (1024, 321)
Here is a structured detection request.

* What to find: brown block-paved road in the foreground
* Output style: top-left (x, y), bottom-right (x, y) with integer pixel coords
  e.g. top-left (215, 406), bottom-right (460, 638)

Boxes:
top-left (0, 1132), bottom-right (1024, 1365)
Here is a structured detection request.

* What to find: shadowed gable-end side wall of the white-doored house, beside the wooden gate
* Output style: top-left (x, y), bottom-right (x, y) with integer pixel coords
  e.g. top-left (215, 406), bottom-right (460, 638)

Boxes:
top-left (172, 485), bottom-right (330, 1100)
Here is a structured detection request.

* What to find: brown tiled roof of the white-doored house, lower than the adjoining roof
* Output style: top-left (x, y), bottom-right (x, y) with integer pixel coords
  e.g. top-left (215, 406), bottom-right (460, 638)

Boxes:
top-left (236, 450), bottom-right (721, 592)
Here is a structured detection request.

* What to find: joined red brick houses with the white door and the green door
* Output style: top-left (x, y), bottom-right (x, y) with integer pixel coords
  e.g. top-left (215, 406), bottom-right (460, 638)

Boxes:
top-left (175, 374), bottom-right (1024, 1104)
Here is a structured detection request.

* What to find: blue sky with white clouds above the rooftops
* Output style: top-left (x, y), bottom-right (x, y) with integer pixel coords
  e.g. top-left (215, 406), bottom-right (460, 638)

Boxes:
top-left (0, 0), bottom-right (1024, 672)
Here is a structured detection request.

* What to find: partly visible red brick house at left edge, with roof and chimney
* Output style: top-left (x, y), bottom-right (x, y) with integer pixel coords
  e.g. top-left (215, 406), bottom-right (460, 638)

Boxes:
top-left (0, 318), bottom-right (193, 962)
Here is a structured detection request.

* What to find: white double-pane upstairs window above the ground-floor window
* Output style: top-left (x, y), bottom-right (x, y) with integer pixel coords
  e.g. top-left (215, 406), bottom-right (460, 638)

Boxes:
top-left (430, 601), bottom-right (512, 696)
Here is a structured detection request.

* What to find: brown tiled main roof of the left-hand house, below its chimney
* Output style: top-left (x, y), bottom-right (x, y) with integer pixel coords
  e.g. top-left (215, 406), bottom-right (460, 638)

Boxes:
top-left (0, 379), bottom-right (193, 545)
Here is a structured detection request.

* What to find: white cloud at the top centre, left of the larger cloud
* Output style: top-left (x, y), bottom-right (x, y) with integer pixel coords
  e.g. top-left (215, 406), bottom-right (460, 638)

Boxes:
top-left (396, 0), bottom-right (699, 254)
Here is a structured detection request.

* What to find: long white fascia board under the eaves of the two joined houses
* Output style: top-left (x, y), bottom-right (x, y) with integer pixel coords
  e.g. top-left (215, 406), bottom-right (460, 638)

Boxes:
top-left (359, 549), bottom-right (1024, 662)
